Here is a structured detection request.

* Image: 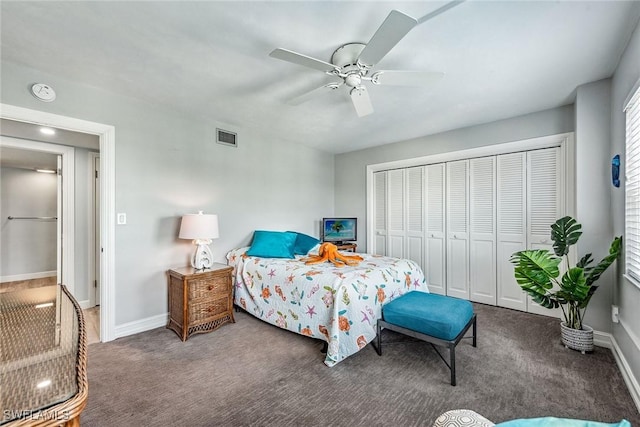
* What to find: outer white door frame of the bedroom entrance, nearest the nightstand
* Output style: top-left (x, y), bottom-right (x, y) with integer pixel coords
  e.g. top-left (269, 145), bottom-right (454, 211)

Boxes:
top-left (0, 103), bottom-right (116, 342)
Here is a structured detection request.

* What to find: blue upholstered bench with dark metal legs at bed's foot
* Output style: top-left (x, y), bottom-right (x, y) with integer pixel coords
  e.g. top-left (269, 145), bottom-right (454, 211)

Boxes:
top-left (374, 291), bottom-right (476, 385)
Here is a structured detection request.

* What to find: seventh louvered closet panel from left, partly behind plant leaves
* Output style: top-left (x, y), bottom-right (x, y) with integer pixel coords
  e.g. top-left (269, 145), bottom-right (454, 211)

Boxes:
top-left (496, 153), bottom-right (527, 311)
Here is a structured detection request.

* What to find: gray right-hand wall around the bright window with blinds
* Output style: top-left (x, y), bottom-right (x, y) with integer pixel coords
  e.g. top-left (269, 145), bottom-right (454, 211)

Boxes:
top-left (609, 18), bottom-right (640, 394)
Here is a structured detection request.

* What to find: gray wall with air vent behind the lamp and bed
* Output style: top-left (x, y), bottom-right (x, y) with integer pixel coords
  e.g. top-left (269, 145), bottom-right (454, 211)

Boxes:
top-left (0, 62), bottom-right (334, 326)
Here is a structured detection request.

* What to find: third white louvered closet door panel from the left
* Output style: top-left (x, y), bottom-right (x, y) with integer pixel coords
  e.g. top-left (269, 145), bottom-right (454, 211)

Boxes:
top-left (406, 167), bottom-right (424, 270)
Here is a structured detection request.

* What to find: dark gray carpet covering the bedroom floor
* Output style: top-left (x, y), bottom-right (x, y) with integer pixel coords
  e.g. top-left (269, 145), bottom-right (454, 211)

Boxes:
top-left (82, 304), bottom-right (640, 426)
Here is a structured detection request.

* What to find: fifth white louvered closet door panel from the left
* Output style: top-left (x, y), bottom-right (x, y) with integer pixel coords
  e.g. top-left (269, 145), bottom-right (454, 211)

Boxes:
top-left (447, 160), bottom-right (469, 299)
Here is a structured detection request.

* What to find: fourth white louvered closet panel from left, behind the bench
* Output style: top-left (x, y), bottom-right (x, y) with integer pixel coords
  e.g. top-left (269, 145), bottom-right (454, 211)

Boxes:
top-left (424, 163), bottom-right (447, 295)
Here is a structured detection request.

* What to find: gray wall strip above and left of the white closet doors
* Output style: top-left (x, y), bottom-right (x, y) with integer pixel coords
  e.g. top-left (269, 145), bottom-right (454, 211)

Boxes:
top-left (335, 105), bottom-right (574, 251)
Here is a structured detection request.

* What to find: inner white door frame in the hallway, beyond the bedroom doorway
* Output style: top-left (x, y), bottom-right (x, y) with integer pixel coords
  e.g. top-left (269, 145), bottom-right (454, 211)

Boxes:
top-left (0, 136), bottom-right (75, 295)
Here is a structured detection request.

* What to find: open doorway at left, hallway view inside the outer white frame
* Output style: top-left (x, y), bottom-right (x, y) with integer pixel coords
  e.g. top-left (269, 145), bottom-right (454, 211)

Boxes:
top-left (0, 137), bottom-right (100, 343)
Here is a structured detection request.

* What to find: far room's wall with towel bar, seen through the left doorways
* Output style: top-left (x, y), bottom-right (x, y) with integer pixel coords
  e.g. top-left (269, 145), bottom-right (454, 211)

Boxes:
top-left (0, 167), bottom-right (58, 277)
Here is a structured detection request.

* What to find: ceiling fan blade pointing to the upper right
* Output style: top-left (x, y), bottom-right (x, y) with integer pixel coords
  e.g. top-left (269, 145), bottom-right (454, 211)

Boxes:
top-left (358, 10), bottom-right (418, 66)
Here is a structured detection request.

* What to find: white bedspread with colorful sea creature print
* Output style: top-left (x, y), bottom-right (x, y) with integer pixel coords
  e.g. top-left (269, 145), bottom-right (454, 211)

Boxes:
top-left (227, 248), bottom-right (428, 366)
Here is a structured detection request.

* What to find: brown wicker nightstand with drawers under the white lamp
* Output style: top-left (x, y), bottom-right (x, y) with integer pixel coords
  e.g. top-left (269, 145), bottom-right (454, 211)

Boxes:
top-left (167, 263), bottom-right (235, 341)
